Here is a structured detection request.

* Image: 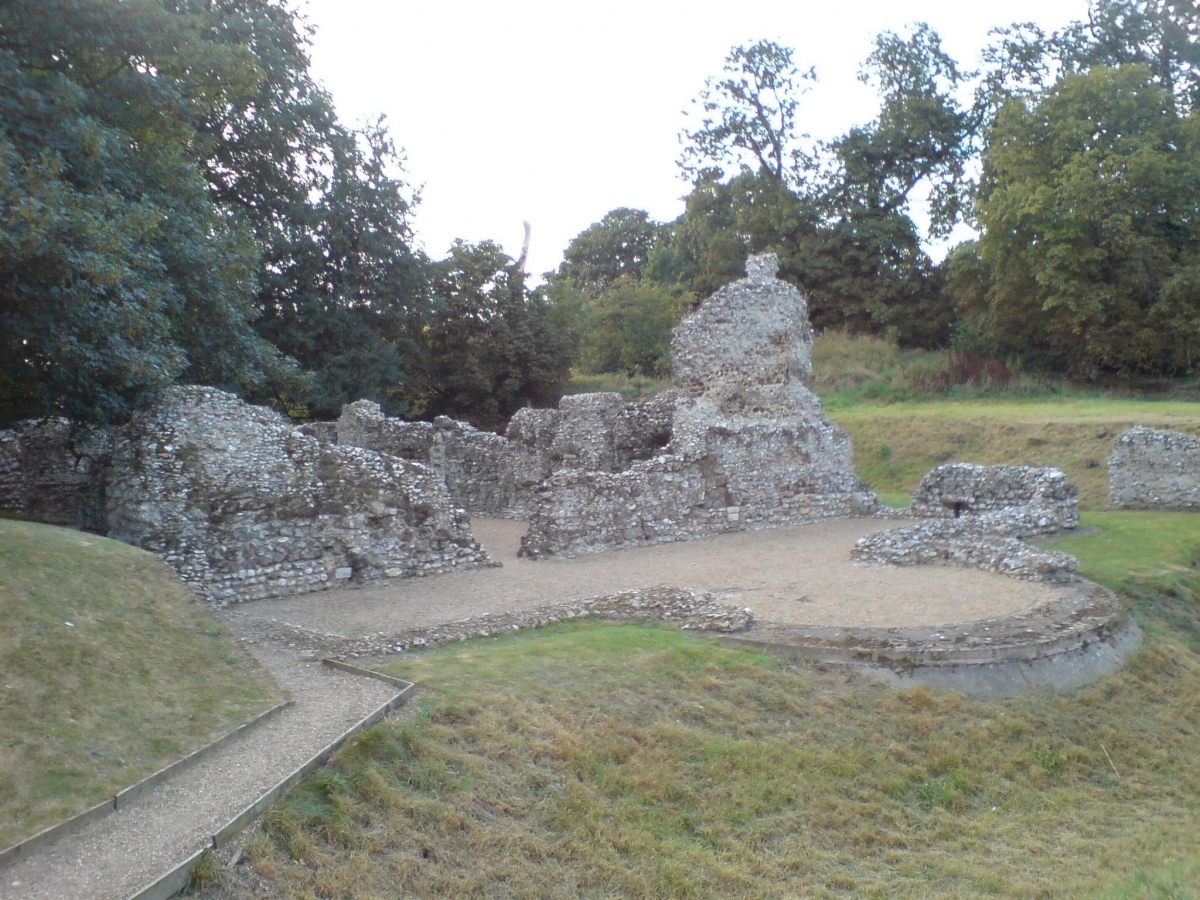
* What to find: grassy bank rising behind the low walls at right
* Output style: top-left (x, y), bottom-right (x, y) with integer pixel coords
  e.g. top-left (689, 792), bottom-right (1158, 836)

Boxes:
top-left (827, 397), bottom-right (1200, 510)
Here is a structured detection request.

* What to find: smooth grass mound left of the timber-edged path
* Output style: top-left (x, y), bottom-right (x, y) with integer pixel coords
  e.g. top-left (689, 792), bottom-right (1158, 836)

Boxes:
top-left (0, 520), bottom-right (278, 846)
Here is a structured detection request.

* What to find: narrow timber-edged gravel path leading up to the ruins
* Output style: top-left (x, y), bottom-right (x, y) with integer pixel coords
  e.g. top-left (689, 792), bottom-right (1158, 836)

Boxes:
top-left (0, 647), bottom-right (396, 900)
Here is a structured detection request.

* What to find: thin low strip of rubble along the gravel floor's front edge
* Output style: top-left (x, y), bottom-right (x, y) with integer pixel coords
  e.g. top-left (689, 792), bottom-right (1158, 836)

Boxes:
top-left (238, 584), bottom-right (754, 660)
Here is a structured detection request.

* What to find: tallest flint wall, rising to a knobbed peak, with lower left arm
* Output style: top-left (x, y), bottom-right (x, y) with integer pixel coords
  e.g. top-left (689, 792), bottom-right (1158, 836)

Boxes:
top-left (521, 257), bottom-right (878, 557)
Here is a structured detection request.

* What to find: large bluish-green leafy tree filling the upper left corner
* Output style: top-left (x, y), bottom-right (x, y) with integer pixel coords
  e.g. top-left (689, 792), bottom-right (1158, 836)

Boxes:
top-left (0, 0), bottom-right (288, 422)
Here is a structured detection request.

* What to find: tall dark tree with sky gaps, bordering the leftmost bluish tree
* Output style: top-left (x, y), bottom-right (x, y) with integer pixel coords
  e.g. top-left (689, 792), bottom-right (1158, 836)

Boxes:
top-left (187, 0), bottom-right (428, 416)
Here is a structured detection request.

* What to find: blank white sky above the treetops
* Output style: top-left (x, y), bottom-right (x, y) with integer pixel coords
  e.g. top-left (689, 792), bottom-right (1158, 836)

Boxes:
top-left (300, 0), bottom-right (1087, 276)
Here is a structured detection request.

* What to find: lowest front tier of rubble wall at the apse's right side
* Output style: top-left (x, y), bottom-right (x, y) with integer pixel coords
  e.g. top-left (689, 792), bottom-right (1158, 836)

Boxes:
top-left (850, 516), bottom-right (1079, 582)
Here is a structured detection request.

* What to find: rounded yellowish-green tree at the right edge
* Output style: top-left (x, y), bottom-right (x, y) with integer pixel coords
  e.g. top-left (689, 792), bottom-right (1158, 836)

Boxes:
top-left (978, 65), bottom-right (1200, 376)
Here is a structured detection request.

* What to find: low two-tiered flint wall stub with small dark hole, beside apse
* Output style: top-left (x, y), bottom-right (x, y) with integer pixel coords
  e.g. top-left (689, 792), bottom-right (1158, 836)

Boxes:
top-left (851, 463), bottom-right (1079, 582)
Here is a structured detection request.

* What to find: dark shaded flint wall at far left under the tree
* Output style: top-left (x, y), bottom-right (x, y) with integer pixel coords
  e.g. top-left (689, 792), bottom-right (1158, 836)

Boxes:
top-left (0, 419), bottom-right (112, 534)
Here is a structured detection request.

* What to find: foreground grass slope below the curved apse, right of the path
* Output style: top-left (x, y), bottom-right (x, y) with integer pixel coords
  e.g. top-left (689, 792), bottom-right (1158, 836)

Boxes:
top-left (234, 514), bottom-right (1200, 899)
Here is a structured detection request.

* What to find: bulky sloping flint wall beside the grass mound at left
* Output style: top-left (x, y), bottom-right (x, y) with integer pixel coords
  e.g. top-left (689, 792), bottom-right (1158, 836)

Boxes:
top-left (107, 386), bottom-right (490, 606)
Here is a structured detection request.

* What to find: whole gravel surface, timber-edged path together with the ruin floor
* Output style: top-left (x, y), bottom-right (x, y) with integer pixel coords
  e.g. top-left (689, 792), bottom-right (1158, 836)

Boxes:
top-left (0, 518), bottom-right (1056, 900)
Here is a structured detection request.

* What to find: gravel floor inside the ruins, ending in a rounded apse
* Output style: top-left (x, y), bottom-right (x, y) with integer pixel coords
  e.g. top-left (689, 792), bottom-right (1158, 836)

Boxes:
top-left (224, 518), bottom-right (1057, 637)
